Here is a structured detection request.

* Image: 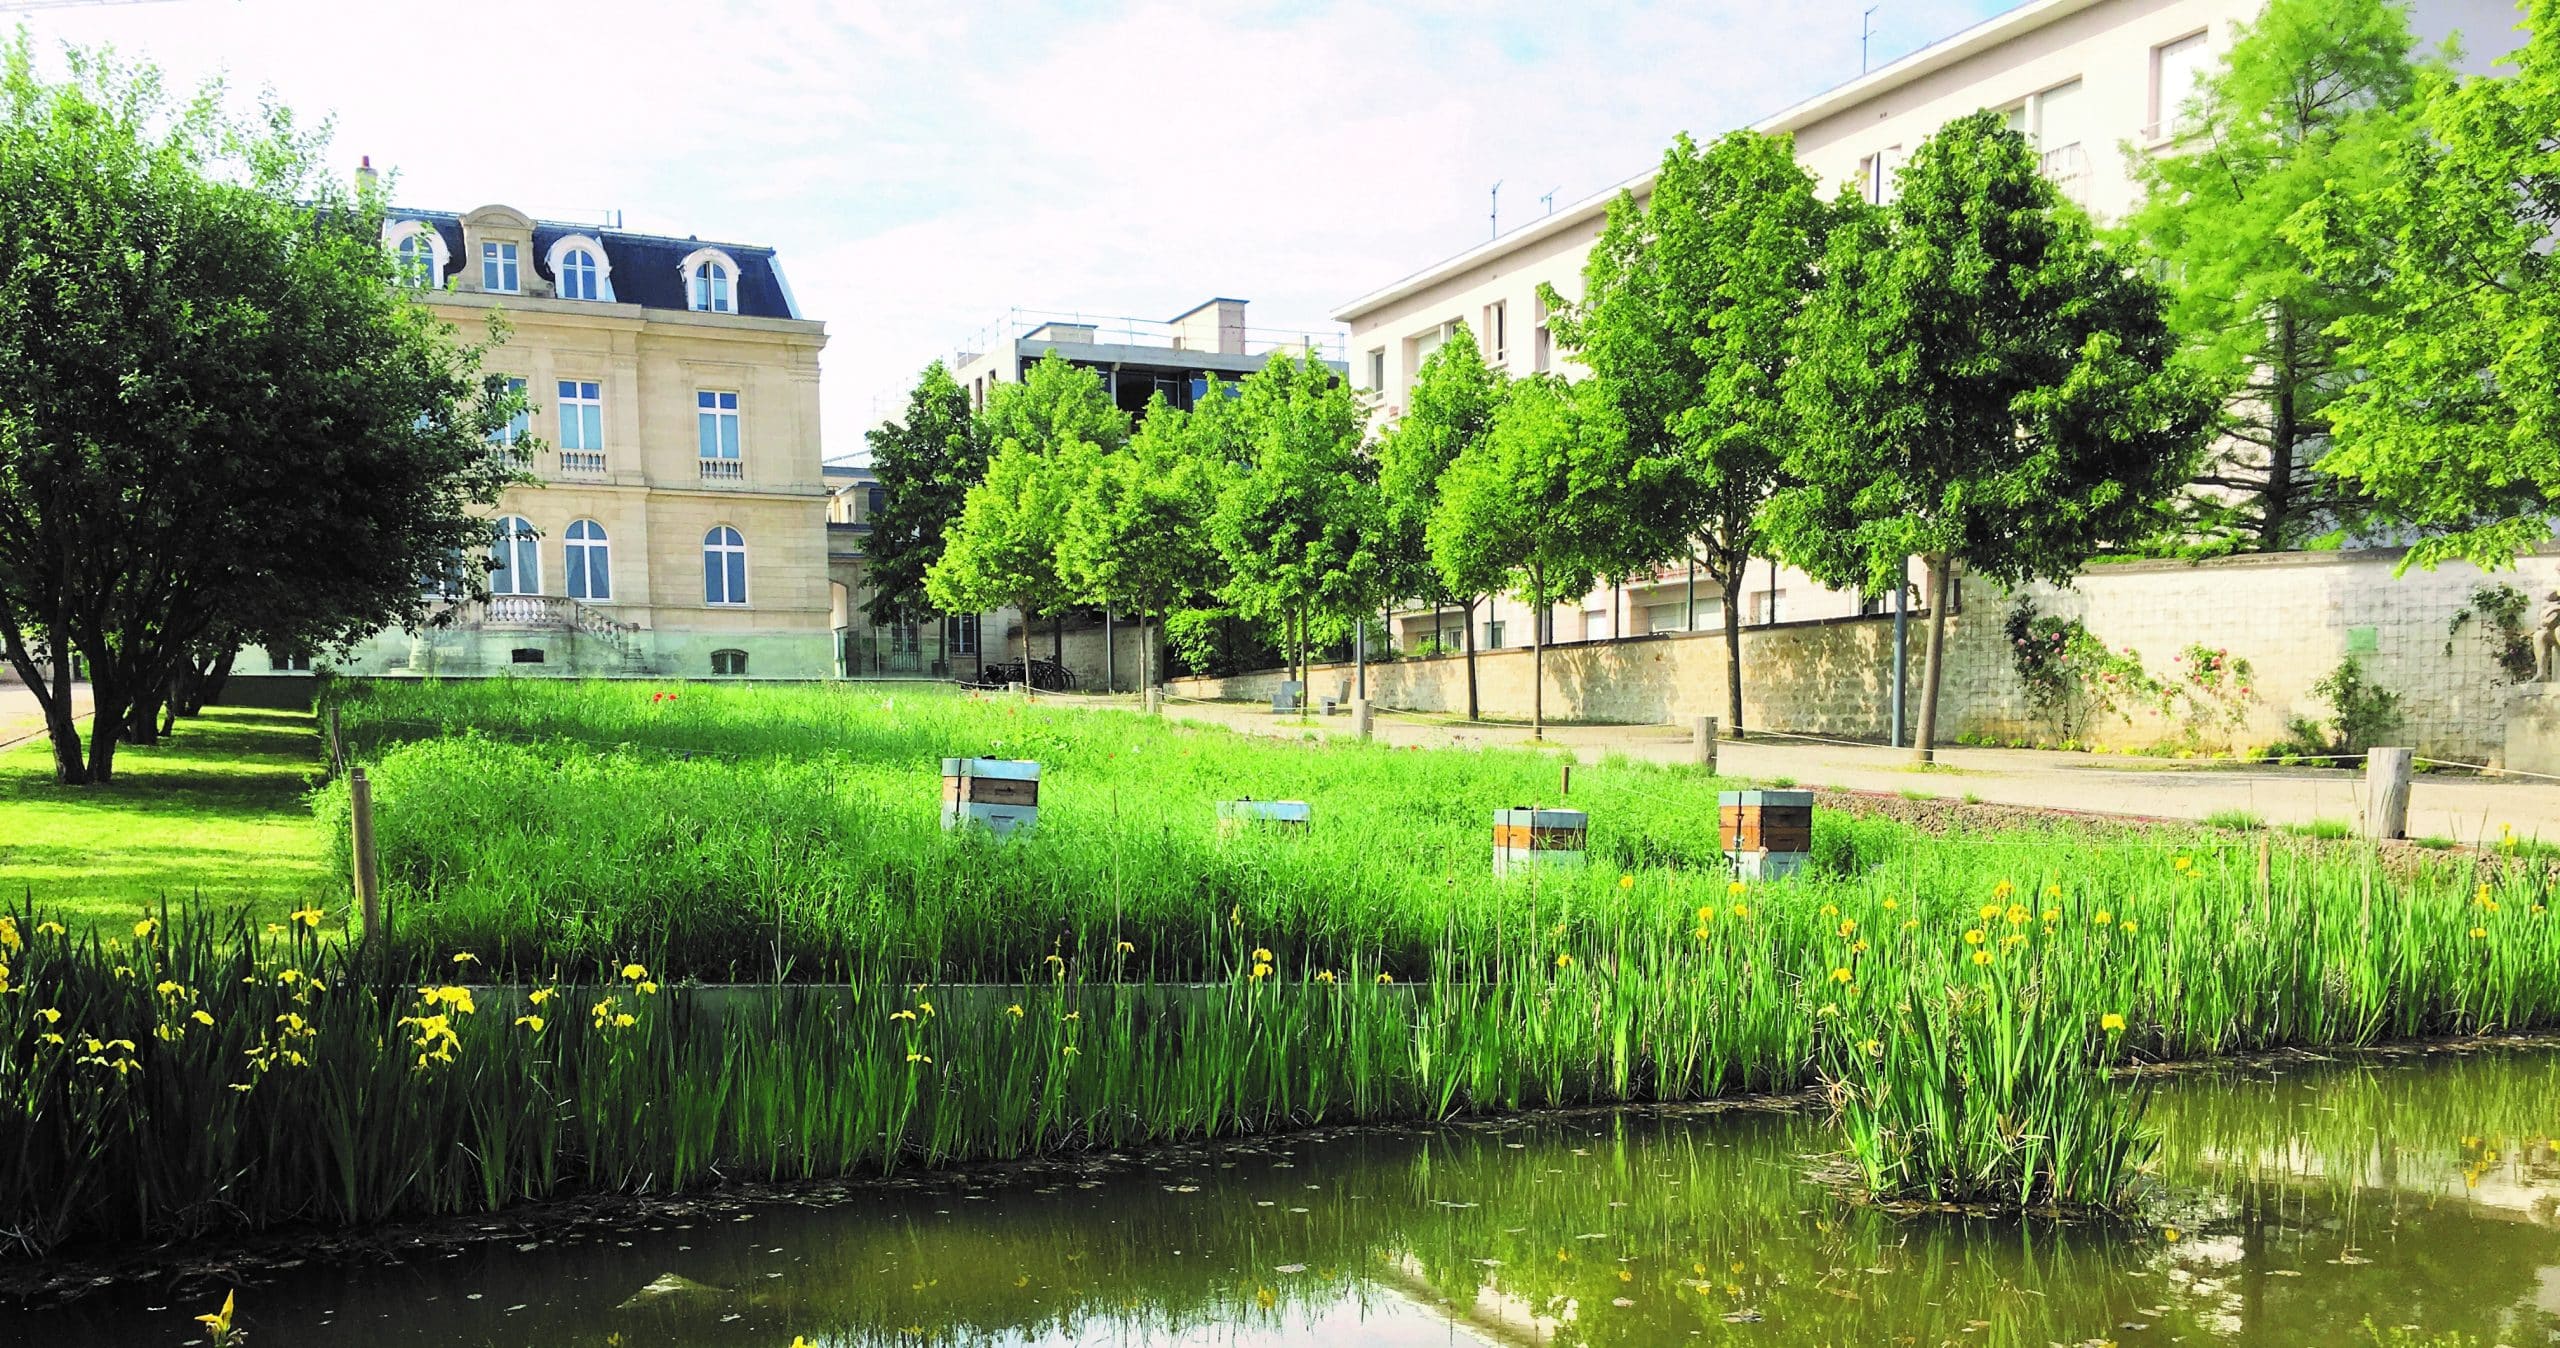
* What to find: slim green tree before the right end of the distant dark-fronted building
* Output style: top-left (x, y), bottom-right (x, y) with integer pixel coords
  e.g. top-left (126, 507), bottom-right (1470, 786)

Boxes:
top-left (1208, 350), bottom-right (1390, 695)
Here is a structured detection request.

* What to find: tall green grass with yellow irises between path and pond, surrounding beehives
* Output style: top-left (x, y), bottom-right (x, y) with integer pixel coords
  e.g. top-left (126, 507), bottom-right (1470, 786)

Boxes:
top-left (0, 683), bottom-right (2560, 1248)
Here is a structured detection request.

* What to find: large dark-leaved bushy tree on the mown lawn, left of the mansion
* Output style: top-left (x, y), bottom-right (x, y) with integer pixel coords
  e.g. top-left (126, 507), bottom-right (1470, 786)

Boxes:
top-left (0, 33), bottom-right (522, 783)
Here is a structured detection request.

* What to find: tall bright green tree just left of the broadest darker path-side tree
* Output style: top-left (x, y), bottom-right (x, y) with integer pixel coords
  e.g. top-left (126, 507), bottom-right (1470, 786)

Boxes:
top-left (1546, 130), bottom-right (1825, 737)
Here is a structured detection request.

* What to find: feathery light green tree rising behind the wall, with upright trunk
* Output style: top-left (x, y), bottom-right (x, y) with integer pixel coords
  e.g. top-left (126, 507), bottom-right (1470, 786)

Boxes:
top-left (2125, 0), bottom-right (2417, 553)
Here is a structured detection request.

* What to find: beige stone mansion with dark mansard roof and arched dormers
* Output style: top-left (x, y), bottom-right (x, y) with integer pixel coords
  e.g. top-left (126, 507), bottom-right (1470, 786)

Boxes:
top-left (258, 205), bottom-right (837, 678)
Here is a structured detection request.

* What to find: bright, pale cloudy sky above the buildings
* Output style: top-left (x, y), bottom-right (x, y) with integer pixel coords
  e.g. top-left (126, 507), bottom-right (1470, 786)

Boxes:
top-left (20, 0), bottom-right (2015, 458)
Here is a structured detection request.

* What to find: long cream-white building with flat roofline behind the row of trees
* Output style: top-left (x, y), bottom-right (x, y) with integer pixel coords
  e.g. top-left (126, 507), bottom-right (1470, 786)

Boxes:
top-left (1334, 0), bottom-right (2522, 650)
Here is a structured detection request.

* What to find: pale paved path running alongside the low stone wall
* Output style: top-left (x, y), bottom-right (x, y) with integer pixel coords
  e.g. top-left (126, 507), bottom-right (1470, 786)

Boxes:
top-left (1093, 698), bottom-right (2560, 844)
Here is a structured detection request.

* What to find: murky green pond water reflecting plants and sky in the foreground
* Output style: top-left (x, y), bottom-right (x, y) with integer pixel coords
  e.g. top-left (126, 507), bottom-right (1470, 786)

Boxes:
top-left (20, 1049), bottom-right (2560, 1348)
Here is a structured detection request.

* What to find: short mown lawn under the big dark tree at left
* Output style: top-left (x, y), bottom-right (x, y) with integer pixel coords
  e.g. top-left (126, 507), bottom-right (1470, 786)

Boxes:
top-left (0, 709), bottom-right (330, 929)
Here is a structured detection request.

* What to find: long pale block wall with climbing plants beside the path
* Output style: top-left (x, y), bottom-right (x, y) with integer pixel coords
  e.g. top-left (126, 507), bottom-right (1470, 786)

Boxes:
top-left (1170, 550), bottom-right (2560, 762)
